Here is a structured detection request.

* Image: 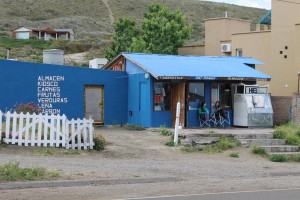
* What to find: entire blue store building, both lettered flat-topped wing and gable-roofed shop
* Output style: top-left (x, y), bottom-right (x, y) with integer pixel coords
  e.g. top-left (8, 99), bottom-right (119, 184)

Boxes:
top-left (0, 53), bottom-right (271, 127)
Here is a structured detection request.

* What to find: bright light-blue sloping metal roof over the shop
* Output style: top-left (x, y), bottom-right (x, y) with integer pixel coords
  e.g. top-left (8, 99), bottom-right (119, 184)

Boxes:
top-left (122, 53), bottom-right (271, 81)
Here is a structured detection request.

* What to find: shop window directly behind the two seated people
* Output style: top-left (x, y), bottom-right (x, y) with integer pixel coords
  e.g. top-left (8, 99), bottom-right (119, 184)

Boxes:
top-left (211, 83), bottom-right (231, 108)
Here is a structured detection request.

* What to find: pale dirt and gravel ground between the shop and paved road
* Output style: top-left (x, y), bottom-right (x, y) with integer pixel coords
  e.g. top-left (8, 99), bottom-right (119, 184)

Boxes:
top-left (0, 126), bottom-right (300, 200)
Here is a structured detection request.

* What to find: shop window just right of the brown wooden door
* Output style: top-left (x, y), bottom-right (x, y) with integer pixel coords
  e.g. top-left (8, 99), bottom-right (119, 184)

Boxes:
top-left (188, 83), bottom-right (204, 110)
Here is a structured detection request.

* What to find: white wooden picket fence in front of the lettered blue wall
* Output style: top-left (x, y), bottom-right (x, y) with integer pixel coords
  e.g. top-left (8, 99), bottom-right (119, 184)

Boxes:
top-left (0, 111), bottom-right (94, 150)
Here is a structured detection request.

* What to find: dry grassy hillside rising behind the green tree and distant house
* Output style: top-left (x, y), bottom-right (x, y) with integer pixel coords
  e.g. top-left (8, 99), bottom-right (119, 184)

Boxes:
top-left (0, 0), bottom-right (266, 61)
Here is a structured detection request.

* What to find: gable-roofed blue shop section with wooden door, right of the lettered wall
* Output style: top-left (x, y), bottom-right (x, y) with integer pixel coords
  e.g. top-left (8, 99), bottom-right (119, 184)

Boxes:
top-left (104, 53), bottom-right (271, 127)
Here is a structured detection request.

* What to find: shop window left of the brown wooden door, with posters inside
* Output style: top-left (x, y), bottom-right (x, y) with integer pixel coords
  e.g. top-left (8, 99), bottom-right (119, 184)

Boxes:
top-left (153, 82), bottom-right (171, 111)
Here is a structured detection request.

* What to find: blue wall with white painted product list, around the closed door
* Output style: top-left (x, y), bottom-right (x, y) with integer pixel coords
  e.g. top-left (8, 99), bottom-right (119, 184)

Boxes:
top-left (0, 60), bottom-right (128, 124)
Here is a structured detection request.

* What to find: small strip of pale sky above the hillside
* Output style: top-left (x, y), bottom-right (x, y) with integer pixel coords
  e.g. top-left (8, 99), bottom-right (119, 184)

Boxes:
top-left (208, 0), bottom-right (271, 10)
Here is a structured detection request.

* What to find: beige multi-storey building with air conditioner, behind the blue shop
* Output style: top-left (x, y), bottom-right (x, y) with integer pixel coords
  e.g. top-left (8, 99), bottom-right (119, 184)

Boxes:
top-left (179, 0), bottom-right (300, 96)
